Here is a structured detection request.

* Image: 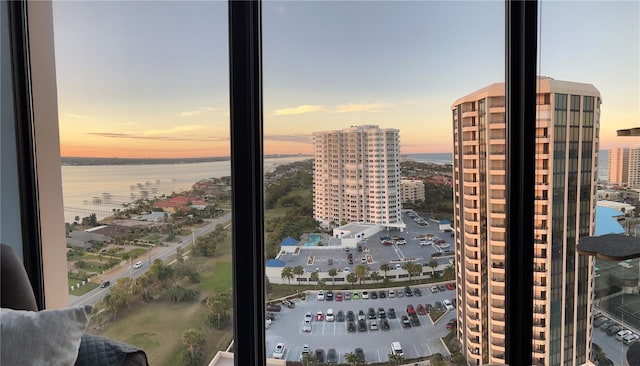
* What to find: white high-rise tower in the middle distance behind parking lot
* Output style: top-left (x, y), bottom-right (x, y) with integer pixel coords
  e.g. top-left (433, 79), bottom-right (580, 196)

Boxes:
top-left (313, 125), bottom-right (404, 227)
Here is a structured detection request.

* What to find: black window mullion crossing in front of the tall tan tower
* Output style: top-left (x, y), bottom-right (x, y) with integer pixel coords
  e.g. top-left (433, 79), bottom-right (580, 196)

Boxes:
top-left (505, 0), bottom-right (538, 365)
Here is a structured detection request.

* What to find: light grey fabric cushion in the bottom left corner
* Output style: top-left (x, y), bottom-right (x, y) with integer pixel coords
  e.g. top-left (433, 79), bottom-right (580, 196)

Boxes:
top-left (0, 305), bottom-right (91, 366)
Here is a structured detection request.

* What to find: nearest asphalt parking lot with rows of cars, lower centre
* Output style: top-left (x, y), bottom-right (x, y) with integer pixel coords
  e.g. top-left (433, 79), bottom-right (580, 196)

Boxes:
top-left (266, 283), bottom-right (456, 363)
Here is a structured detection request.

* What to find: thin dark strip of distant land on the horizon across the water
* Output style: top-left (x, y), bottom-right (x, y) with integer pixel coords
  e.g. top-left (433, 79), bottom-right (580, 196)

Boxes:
top-left (60, 154), bottom-right (310, 165)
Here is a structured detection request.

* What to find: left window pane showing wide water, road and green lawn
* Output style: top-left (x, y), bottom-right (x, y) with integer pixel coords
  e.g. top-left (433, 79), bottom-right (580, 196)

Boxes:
top-left (53, 1), bottom-right (233, 365)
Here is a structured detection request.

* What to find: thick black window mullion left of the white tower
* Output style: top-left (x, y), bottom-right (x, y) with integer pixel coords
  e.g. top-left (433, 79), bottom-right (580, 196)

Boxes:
top-left (229, 0), bottom-right (266, 366)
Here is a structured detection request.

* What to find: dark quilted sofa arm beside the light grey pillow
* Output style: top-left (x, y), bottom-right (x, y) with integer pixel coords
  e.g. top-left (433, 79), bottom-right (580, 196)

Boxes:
top-left (75, 334), bottom-right (149, 366)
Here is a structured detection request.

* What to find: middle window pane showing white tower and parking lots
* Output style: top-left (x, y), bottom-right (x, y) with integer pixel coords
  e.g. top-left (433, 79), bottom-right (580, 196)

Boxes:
top-left (262, 1), bottom-right (506, 364)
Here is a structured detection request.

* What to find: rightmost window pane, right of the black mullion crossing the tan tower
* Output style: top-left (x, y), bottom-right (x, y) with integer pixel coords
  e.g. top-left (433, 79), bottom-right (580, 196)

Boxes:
top-left (534, 1), bottom-right (640, 365)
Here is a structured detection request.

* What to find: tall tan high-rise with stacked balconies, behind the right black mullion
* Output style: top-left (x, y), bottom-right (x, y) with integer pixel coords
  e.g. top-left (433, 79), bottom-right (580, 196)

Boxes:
top-left (452, 78), bottom-right (600, 365)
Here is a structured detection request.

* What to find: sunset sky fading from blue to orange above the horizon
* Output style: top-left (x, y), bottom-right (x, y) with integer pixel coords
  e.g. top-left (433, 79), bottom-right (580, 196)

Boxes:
top-left (53, 0), bottom-right (640, 158)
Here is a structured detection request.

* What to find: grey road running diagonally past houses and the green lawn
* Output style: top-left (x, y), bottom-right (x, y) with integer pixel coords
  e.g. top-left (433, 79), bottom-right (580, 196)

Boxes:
top-left (69, 212), bottom-right (231, 306)
